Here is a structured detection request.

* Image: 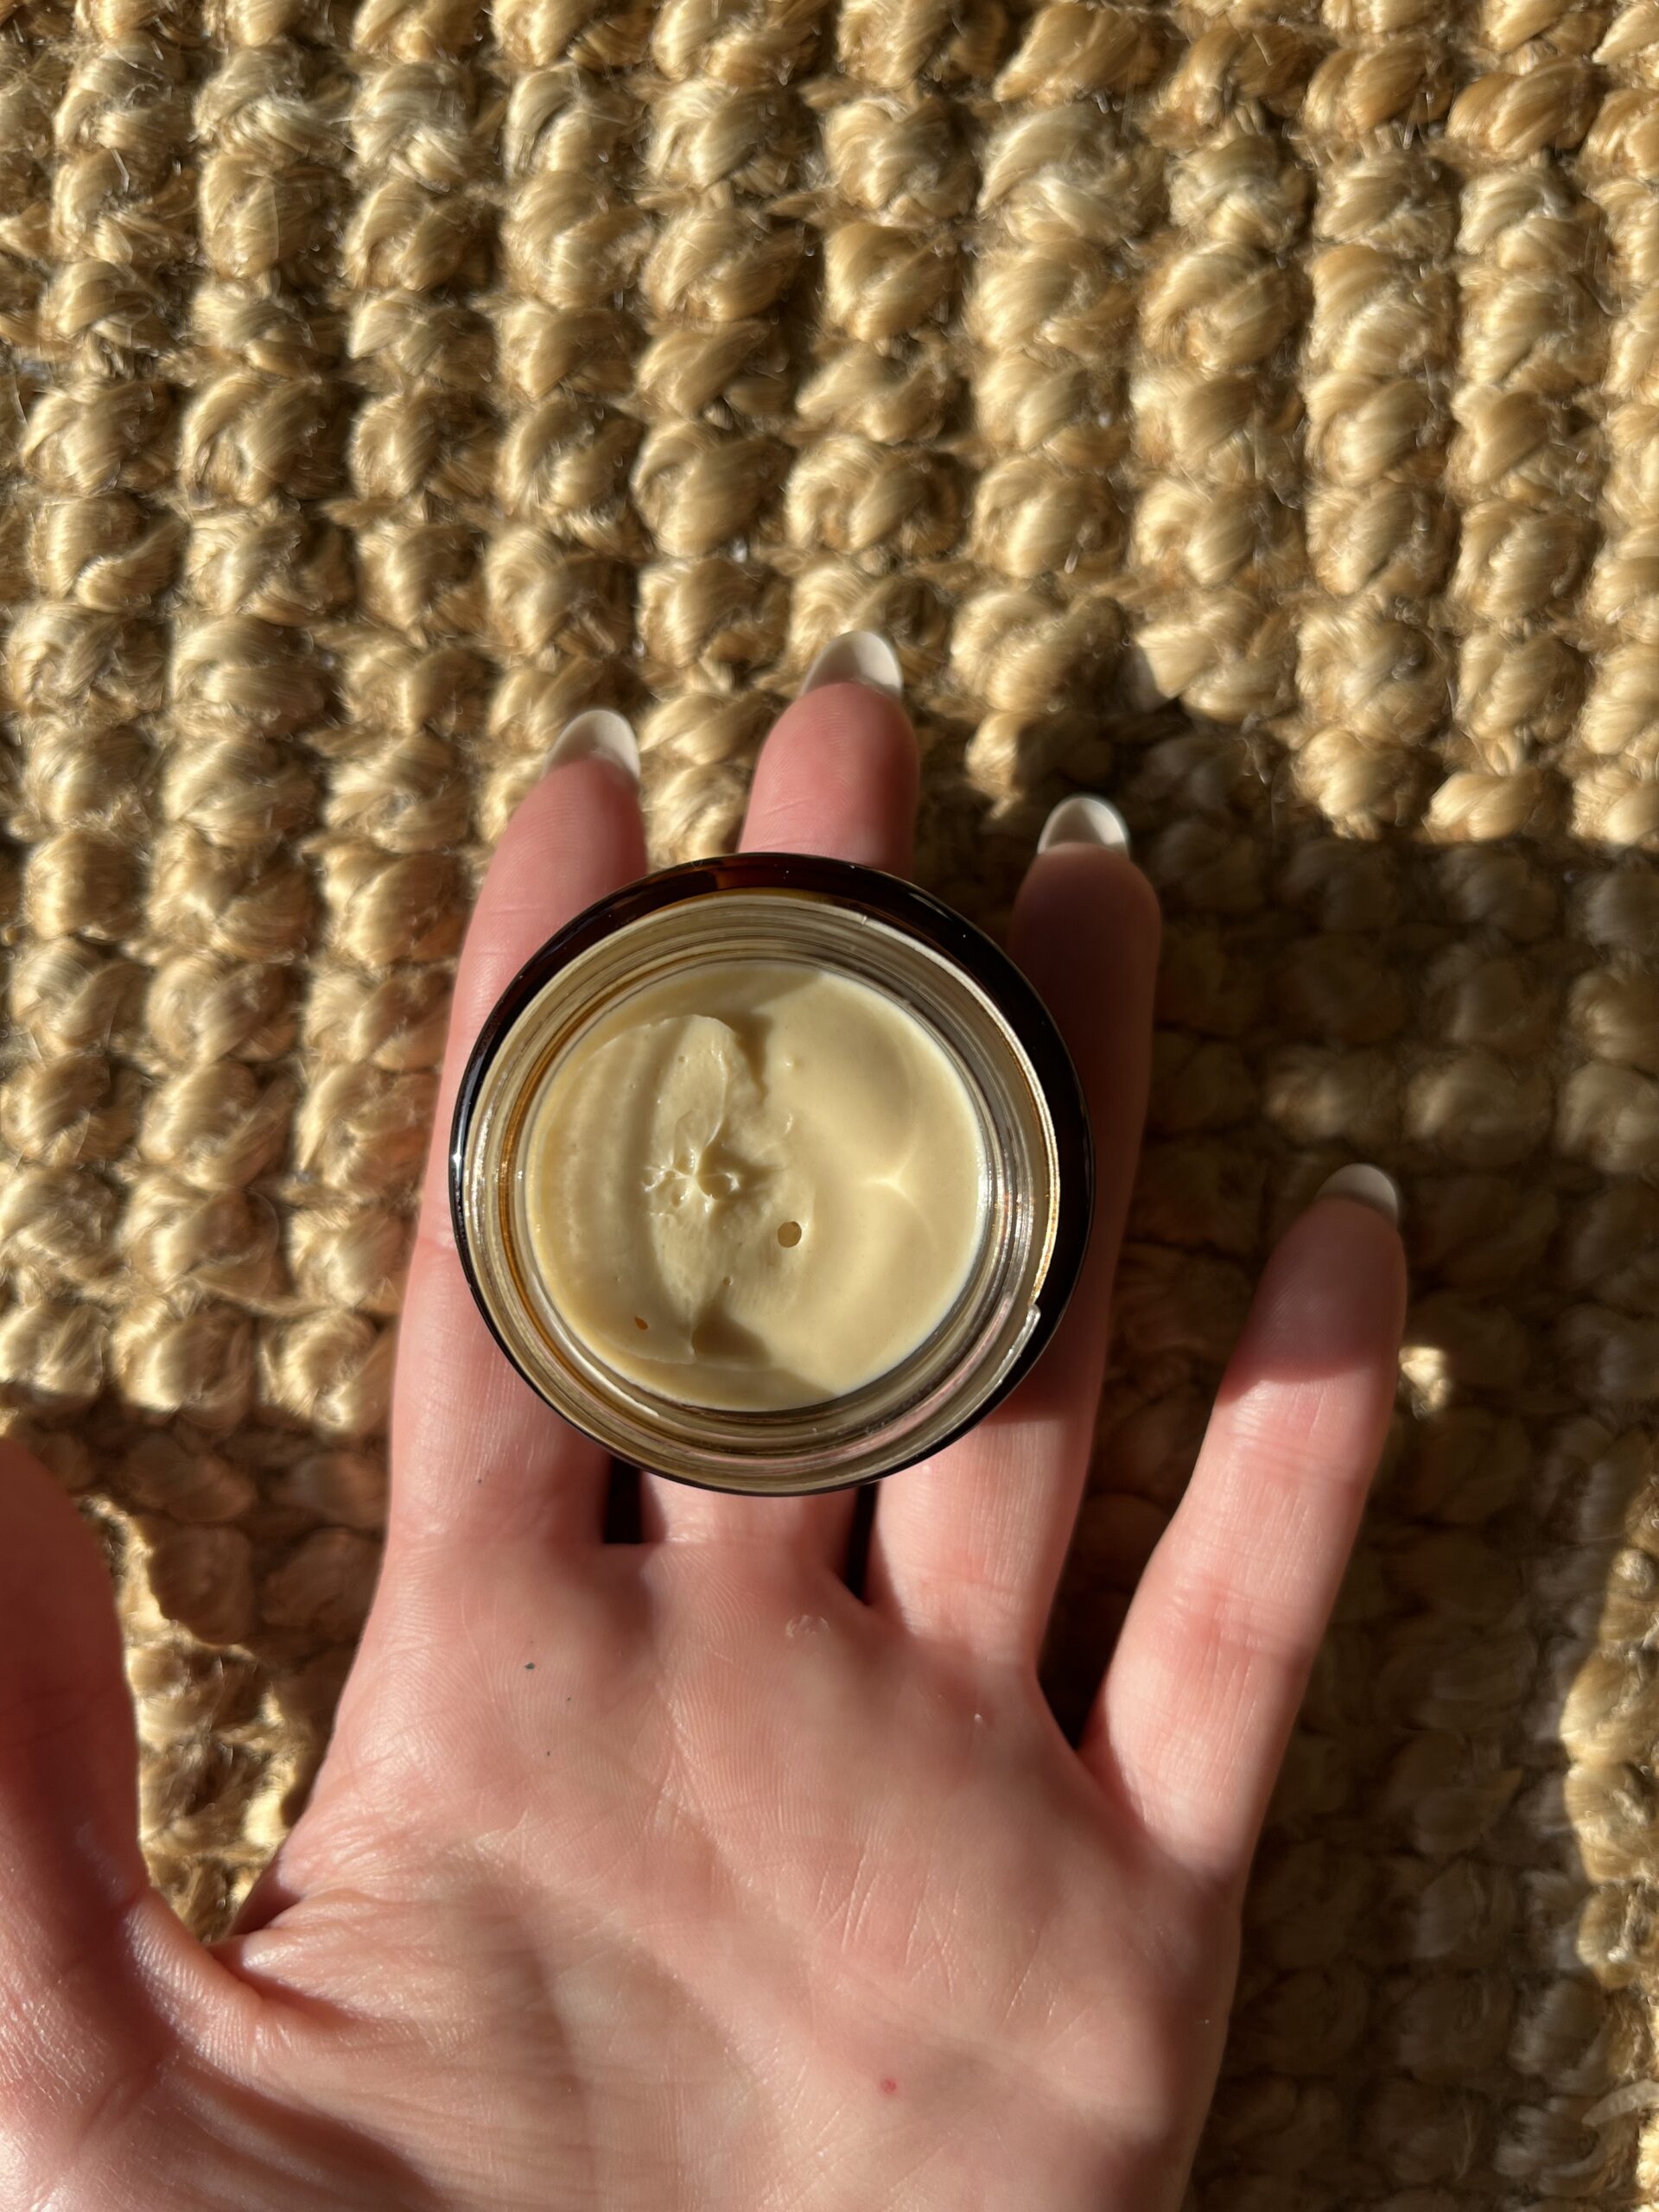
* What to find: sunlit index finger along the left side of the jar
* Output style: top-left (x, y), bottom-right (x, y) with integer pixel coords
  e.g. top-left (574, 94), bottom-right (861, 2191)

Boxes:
top-left (387, 734), bottom-right (646, 1573)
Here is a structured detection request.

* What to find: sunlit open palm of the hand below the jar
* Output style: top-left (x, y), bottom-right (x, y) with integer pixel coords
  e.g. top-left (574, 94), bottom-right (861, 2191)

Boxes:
top-left (55, 1561), bottom-right (1228, 2212)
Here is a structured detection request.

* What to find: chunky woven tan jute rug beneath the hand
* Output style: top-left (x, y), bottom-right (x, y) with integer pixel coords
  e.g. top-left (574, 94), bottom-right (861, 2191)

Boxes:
top-left (0, 0), bottom-right (1659, 2212)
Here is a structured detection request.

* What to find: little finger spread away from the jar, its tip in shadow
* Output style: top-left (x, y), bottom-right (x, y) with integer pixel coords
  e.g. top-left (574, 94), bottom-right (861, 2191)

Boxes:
top-left (1084, 1197), bottom-right (1405, 1883)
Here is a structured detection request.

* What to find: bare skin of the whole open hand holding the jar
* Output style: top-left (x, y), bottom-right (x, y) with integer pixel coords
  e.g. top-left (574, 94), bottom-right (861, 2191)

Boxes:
top-left (0, 683), bottom-right (1405, 2212)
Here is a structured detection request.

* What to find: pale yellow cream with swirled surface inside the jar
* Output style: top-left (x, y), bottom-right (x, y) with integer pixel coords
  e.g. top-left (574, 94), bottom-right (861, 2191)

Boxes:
top-left (520, 960), bottom-right (984, 1409)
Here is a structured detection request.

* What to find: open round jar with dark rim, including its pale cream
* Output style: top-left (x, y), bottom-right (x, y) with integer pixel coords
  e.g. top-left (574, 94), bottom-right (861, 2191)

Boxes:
top-left (449, 854), bottom-right (1093, 1493)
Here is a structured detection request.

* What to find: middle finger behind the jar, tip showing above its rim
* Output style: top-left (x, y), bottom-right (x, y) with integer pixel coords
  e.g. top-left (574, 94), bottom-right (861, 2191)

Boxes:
top-left (641, 639), bottom-right (918, 1571)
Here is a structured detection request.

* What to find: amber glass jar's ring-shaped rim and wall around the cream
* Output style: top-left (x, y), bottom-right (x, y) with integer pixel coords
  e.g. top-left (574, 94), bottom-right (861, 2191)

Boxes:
top-left (449, 854), bottom-right (1093, 1493)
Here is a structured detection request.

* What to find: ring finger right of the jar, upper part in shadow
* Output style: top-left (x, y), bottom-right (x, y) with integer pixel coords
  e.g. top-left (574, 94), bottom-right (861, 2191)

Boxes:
top-left (869, 823), bottom-right (1159, 1663)
